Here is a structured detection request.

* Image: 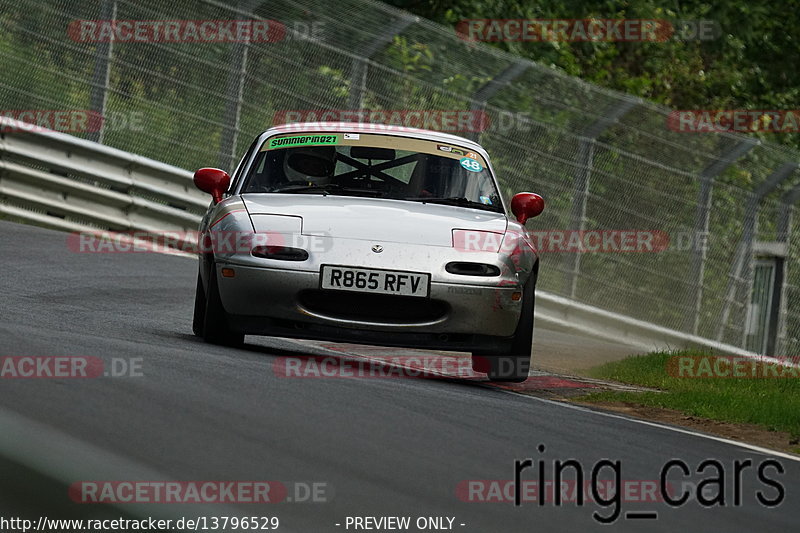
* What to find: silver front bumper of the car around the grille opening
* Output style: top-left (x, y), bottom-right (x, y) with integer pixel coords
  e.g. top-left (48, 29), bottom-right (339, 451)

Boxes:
top-left (216, 262), bottom-right (523, 340)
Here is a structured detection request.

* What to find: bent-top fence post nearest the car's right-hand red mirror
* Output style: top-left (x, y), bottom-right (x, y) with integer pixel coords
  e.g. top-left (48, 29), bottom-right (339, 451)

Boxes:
top-left (564, 99), bottom-right (636, 299)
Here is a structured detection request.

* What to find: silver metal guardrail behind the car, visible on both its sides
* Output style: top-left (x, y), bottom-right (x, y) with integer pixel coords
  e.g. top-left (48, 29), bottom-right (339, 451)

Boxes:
top-left (0, 118), bottom-right (755, 356)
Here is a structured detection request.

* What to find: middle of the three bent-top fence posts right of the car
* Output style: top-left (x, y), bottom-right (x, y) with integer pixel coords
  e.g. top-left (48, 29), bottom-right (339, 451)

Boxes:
top-left (684, 138), bottom-right (759, 335)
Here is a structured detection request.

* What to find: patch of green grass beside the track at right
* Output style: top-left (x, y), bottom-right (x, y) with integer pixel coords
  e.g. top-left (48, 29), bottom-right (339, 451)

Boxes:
top-left (580, 351), bottom-right (800, 438)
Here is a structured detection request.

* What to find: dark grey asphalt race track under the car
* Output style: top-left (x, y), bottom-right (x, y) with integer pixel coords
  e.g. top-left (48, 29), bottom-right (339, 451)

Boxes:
top-left (0, 222), bottom-right (800, 533)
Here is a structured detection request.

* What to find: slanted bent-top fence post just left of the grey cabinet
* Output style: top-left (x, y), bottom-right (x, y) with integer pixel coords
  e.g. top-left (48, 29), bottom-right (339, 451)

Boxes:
top-left (716, 162), bottom-right (798, 346)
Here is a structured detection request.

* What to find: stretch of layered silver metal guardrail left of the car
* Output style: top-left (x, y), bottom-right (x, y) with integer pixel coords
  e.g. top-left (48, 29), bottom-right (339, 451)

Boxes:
top-left (0, 117), bottom-right (208, 235)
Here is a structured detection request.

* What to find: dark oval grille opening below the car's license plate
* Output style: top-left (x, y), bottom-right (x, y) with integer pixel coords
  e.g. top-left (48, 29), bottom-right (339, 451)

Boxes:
top-left (299, 289), bottom-right (450, 324)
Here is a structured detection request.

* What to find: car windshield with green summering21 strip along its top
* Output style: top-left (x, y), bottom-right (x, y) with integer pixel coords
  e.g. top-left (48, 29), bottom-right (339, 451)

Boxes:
top-left (242, 133), bottom-right (503, 212)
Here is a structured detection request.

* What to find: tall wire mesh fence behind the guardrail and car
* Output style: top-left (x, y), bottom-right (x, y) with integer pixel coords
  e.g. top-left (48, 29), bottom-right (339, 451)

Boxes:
top-left (0, 0), bottom-right (800, 355)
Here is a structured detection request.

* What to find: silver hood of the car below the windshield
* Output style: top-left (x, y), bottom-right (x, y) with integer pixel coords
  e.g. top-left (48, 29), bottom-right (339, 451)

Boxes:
top-left (242, 194), bottom-right (508, 246)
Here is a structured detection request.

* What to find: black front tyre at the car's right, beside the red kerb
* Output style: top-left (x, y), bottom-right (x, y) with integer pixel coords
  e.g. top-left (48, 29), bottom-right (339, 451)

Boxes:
top-left (472, 279), bottom-right (536, 383)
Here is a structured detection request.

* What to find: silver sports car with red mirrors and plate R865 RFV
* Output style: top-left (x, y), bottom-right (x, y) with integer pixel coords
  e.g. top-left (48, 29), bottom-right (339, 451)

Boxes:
top-left (194, 123), bottom-right (544, 381)
